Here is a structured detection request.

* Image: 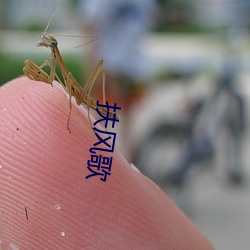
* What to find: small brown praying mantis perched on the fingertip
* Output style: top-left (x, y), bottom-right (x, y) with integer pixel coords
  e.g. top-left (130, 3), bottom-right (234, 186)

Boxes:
top-left (23, 32), bottom-right (115, 133)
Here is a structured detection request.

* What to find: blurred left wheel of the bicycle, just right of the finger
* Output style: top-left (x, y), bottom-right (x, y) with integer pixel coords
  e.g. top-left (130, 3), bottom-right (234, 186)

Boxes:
top-left (133, 123), bottom-right (191, 188)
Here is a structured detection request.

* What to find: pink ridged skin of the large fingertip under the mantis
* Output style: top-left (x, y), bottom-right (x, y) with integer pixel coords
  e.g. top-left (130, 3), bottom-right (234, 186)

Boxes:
top-left (0, 77), bottom-right (213, 250)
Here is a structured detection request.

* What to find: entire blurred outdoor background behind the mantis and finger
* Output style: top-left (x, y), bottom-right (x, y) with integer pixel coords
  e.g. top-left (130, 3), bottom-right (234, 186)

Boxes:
top-left (0, 0), bottom-right (250, 250)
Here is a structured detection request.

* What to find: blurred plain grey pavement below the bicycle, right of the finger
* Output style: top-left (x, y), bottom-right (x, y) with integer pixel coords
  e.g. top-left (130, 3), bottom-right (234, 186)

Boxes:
top-left (132, 81), bottom-right (250, 250)
